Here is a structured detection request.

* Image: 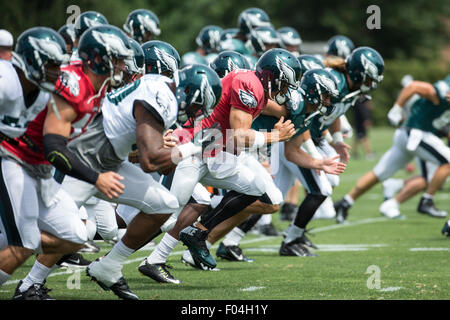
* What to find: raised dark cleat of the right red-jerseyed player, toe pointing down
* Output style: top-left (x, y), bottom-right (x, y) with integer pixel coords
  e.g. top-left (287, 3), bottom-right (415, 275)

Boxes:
top-left (179, 226), bottom-right (217, 269)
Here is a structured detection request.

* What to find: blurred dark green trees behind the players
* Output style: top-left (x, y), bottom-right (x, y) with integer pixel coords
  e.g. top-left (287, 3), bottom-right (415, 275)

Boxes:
top-left (0, 0), bottom-right (450, 125)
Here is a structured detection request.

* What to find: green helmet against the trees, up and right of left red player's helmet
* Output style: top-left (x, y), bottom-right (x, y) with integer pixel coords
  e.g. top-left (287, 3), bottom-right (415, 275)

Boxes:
top-left (123, 9), bottom-right (161, 44)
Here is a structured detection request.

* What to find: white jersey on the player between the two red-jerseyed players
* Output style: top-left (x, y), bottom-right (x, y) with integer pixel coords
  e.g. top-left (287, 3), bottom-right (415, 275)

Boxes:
top-left (101, 74), bottom-right (178, 159)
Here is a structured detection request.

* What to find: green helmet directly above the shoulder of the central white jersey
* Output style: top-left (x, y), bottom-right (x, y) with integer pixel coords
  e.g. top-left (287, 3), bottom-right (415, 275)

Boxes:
top-left (142, 40), bottom-right (181, 78)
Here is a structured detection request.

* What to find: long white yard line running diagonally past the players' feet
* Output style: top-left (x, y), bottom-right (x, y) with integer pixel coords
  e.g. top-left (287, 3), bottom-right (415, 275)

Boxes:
top-left (3, 217), bottom-right (390, 286)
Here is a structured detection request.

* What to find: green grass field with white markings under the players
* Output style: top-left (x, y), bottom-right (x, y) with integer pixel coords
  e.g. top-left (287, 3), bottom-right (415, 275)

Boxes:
top-left (0, 128), bottom-right (450, 300)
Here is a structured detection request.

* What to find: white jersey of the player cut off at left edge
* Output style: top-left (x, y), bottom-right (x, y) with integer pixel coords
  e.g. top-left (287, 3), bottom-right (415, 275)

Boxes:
top-left (0, 59), bottom-right (50, 138)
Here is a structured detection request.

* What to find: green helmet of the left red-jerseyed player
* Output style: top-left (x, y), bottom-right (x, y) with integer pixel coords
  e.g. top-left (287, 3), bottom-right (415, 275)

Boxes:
top-left (78, 25), bottom-right (134, 86)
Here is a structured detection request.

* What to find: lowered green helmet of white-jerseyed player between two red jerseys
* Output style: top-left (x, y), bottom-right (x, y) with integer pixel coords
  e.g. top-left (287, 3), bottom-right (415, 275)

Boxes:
top-left (175, 64), bottom-right (222, 125)
